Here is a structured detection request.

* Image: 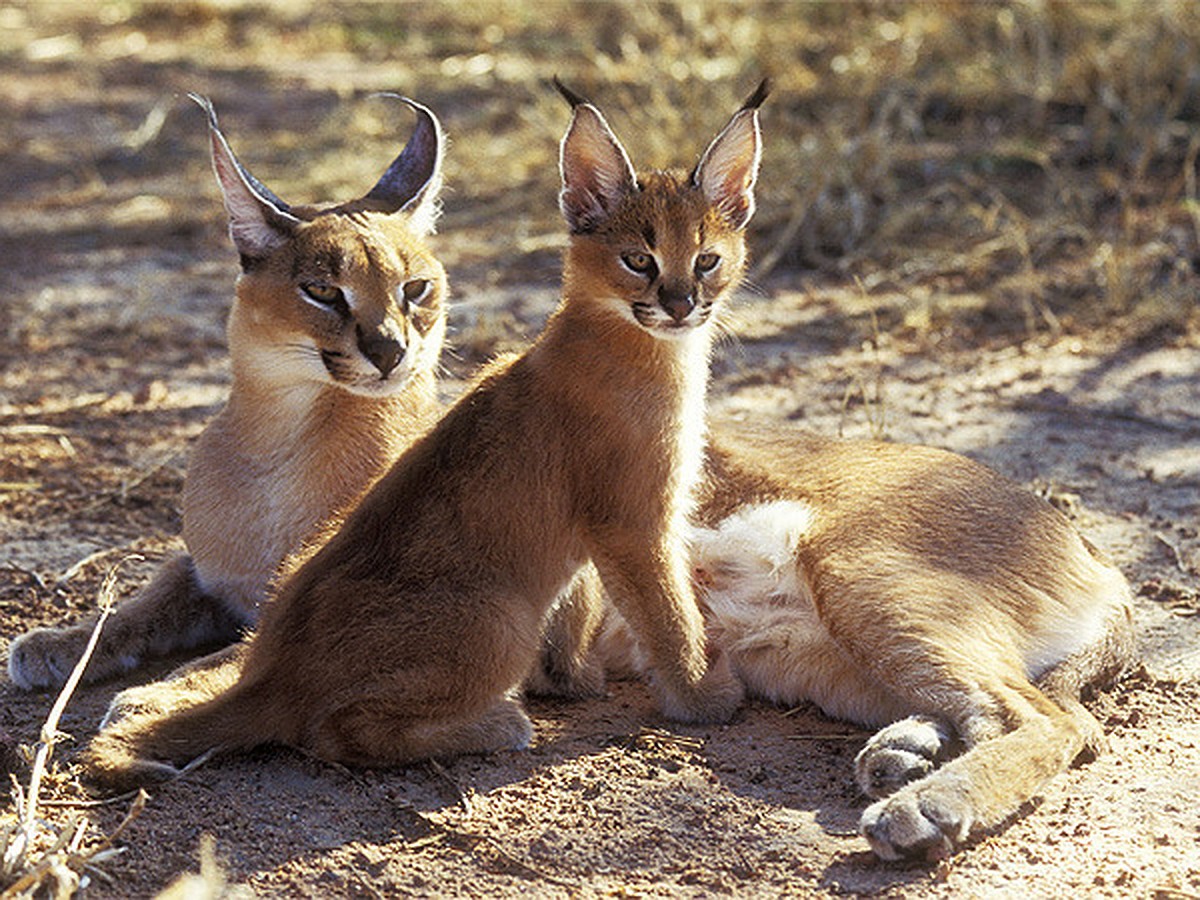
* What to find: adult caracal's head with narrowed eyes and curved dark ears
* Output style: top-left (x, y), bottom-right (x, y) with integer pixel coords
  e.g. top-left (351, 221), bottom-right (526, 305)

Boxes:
top-left (193, 95), bottom-right (448, 397)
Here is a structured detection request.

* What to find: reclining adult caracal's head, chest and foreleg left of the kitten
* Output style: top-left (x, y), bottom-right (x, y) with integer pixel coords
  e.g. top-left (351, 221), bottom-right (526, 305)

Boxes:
top-left (8, 97), bottom-right (448, 689)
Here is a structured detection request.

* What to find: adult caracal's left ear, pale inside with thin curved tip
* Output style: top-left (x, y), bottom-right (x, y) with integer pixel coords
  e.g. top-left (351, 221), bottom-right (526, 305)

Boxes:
top-left (187, 94), bottom-right (300, 269)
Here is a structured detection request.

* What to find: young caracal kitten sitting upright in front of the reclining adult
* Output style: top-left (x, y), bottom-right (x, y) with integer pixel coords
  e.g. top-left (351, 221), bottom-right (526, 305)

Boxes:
top-left (86, 77), bottom-right (766, 785)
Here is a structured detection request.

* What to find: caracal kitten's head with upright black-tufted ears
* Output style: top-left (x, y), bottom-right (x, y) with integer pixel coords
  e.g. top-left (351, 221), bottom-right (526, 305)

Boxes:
top-left (556, 79), bottom-right (768, 338)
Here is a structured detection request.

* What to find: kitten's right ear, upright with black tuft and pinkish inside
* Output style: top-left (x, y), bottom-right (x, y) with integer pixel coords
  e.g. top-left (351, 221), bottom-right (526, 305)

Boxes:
top-left (691, 78), bottom-right (770, 230)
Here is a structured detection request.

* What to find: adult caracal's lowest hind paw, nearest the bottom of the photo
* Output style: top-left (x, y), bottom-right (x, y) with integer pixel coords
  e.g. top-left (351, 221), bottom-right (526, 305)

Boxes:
top-left (859, 776), bottom-right (974, 860)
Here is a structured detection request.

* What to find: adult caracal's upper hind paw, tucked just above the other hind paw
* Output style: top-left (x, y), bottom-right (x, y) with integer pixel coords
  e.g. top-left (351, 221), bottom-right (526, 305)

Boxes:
top-left (854, 715), bottom-right (954, 799)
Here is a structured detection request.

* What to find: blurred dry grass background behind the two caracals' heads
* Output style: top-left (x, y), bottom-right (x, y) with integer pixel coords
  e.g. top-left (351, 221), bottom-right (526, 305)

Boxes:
top-left (0, 0), bottom-right (1200, 350)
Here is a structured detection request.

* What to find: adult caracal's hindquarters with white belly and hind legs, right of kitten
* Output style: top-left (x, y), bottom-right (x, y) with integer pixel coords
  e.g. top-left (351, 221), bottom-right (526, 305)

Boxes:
top-left (692, 434), bottom-right (1134, 859)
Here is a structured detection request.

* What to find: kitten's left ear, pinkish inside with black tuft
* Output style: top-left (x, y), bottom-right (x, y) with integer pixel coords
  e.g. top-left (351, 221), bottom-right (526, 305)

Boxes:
top-left (554, 78), bottom-right (637, 234)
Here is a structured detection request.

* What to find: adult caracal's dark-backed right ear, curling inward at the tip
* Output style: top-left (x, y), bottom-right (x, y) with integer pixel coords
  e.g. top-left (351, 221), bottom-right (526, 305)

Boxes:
top-left (362, 94), bottom-right (445, 234)
